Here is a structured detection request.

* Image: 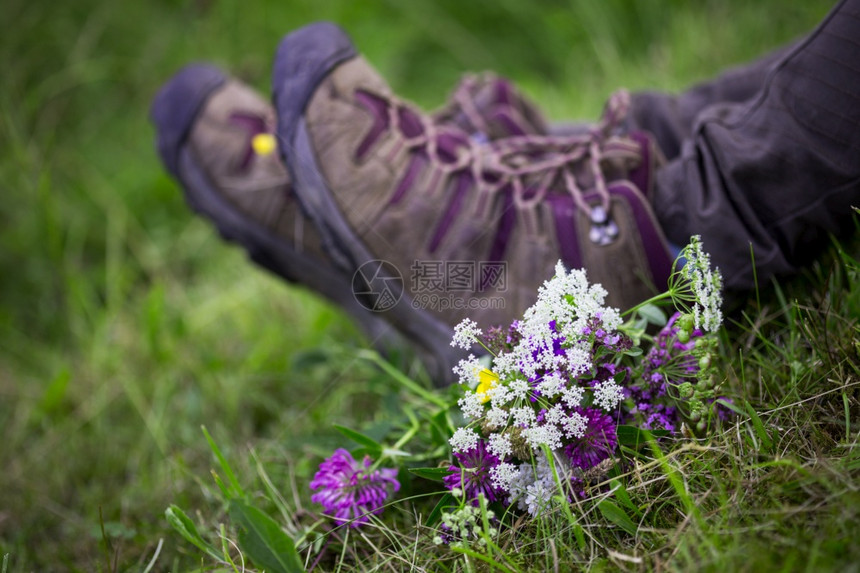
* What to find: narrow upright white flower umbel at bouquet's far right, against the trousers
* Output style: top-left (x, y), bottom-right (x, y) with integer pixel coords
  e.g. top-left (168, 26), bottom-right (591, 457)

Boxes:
top-left (681, 235), bottom-right (723, 332)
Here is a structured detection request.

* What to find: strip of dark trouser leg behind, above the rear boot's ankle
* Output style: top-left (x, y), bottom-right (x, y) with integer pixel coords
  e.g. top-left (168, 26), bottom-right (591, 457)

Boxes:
top-left (628, 42), bottom-right (797, 159)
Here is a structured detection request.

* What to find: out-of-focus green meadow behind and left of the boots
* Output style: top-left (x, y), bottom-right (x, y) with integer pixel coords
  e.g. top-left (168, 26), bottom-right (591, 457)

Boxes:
top-left (0, 0), bottom-right (831, 571)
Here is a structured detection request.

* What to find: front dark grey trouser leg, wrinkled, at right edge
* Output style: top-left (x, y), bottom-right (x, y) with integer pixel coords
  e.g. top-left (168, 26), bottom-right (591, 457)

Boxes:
top-left (653, 0), bottom-right (860, 289)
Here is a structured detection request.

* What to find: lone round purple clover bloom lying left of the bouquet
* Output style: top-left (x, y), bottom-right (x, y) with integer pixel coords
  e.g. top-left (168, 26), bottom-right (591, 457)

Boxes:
top-left (310, 448), bottom-right (400, 527)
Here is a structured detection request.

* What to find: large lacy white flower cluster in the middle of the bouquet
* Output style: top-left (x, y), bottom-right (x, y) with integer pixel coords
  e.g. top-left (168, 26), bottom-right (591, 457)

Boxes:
top-left (450, 262), bottom-right (623, 502)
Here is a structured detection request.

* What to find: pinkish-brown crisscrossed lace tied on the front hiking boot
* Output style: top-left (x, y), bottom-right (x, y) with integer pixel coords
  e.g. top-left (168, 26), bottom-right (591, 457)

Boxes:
top-left (358, 90), bottom-right (642, 244)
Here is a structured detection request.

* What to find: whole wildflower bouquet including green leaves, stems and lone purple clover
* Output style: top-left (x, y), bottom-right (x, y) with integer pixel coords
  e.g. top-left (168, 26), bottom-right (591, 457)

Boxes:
top-left (168, 233), bottom-right (734, 571)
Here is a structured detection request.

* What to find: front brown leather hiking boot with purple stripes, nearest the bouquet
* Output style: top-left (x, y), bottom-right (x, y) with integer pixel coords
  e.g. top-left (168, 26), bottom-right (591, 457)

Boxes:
top-left (273, 23), bottom-right (671, 380)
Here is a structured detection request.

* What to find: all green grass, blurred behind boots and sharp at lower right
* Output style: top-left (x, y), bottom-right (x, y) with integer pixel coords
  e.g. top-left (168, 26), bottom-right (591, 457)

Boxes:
top-left (0, 0), bottom-right (860, 571)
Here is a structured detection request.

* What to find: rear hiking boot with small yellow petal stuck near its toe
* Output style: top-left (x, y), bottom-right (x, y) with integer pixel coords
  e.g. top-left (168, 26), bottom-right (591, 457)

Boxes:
top-left (151, 65), bottom-right (544, 380)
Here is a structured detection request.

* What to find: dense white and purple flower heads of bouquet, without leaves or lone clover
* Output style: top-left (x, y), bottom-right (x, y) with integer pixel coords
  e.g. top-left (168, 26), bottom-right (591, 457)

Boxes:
top-left (444, 237), bottom-right (722, 516)
